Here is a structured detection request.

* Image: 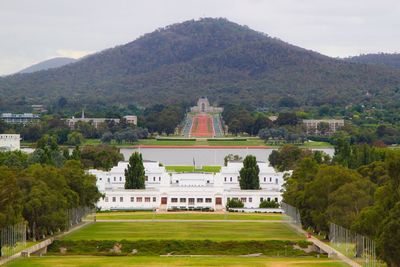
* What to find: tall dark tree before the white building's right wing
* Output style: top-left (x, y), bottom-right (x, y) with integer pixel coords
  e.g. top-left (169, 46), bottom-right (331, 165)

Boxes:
top-left (239, 155), bottom-right (260, 189)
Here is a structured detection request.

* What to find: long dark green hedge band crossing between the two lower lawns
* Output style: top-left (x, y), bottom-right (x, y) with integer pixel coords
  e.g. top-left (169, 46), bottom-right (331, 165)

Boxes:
top-left (48, 240), bottom-right (315, 257)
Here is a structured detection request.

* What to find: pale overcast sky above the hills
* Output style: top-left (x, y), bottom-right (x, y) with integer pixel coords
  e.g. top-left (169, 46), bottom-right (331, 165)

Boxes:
top-left (0, 0), bottom-right (400, 75)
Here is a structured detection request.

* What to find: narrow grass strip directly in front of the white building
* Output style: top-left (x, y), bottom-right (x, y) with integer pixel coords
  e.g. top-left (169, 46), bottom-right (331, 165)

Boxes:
top-left (89, 211), bottom-right (283, 221)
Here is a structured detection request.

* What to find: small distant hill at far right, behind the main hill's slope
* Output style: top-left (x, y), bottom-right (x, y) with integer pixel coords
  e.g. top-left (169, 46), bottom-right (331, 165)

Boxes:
top-left (344, 53), bottom-right (400, 69)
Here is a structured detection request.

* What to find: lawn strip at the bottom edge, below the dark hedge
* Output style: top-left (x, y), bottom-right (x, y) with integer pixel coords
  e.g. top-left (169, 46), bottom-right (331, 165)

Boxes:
top-left (6, 256), bottom-right (346, 267)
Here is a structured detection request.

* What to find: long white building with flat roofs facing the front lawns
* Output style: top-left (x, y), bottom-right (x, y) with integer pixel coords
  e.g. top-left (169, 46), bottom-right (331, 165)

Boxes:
top-left (89, 161), bottom-right (284, 211)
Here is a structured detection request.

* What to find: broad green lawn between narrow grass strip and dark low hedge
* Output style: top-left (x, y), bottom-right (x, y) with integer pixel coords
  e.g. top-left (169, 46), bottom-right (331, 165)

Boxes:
top-left (64, 222), bottom-right (305, 241)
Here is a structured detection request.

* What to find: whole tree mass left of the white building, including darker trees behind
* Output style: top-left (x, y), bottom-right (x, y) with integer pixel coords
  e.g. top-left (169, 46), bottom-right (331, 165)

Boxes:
top-left (0, 138), bottom-right (123, 251)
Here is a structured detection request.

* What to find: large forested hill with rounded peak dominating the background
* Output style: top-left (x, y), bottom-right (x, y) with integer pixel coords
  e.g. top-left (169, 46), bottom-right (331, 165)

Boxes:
top-left (0, 18), bottom-right (400, 110)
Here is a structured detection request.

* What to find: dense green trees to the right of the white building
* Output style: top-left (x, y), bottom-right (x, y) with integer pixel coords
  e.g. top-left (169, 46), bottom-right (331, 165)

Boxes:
top-left (283, 140), bottom-right (400, 266)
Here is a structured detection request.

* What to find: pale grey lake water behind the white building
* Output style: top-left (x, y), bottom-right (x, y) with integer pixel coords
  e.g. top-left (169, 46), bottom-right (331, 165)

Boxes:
top-left (120, 148), bottom-right (334, 166)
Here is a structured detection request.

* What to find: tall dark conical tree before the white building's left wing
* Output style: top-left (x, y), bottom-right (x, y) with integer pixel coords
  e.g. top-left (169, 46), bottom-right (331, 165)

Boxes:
top-left (125, 152), bottom-right (145, 189)
